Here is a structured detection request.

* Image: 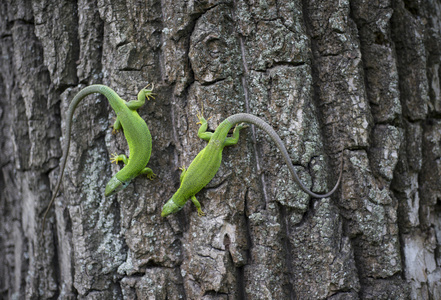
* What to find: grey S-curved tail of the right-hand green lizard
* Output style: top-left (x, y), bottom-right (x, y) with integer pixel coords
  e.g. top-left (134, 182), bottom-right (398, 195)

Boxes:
top-left (226, 113), bottom-right (343, 198)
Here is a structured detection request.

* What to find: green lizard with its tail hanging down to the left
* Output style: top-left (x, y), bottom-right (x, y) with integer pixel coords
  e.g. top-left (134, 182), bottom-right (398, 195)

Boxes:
top-left (42, 84), bottom-right (156, 232)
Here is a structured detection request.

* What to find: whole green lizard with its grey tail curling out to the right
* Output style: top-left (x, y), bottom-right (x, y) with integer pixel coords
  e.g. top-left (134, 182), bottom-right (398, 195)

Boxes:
top-left (161, 113), bottom-right (343, 217)
